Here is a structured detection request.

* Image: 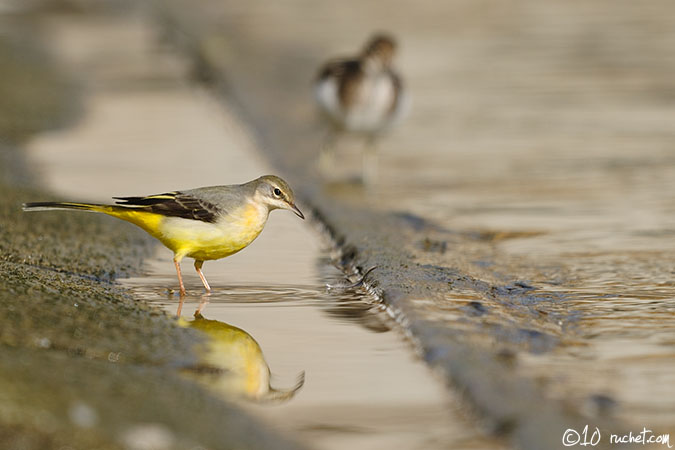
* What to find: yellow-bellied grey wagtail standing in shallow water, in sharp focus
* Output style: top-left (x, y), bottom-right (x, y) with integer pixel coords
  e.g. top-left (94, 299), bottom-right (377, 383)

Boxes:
top-left (23, 175), bottom-right (305, 296)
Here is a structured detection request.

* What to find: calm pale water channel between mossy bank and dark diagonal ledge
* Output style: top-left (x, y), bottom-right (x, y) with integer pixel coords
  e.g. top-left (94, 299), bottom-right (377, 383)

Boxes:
top-left (29, 9), bottom-right (499, 449)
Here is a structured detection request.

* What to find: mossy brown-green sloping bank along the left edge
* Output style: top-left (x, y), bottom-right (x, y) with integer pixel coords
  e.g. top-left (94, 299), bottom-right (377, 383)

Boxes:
top-left (0, 6), bottom-right (300, 450)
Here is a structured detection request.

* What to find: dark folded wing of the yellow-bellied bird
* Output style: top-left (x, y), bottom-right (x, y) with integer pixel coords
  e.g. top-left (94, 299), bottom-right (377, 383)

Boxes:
top-left (113, 192), bottom-right (220, 223)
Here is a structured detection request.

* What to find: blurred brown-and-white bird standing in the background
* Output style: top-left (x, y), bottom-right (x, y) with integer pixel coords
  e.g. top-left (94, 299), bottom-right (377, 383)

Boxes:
top-left (314, 33), bottom-right (408, 183)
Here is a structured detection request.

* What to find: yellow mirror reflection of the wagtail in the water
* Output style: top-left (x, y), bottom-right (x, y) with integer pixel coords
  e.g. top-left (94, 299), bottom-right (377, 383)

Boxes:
top-left (181, 301), bottom-right (305, 403)
